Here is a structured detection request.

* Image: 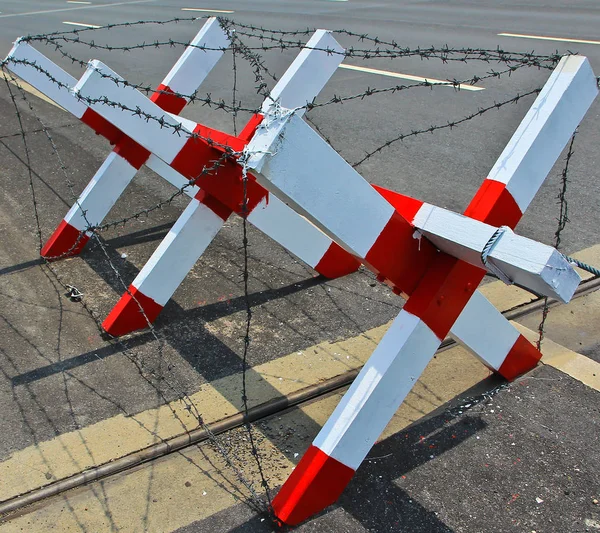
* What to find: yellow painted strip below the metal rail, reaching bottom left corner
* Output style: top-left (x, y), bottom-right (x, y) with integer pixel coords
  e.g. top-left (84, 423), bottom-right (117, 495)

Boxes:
top-left (0, 338), bottom-right (489, 533)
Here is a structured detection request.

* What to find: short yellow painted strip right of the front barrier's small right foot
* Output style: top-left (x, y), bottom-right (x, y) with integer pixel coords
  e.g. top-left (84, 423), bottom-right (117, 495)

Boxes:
top-left (514, 323), bottom-right (600, 391)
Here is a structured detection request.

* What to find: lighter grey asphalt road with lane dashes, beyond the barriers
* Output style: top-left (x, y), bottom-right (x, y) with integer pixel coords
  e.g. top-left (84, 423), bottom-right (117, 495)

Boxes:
top-left (0, 0), bottom-right (600, 251)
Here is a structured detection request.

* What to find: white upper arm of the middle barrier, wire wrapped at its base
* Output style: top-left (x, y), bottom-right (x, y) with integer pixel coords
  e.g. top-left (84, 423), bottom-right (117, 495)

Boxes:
top-left (262, 30), bottom-right (344, 115)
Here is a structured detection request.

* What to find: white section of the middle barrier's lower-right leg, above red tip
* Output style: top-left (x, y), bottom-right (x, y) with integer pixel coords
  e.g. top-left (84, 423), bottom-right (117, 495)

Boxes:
top-left (248, 195), bottom-right (331, 268)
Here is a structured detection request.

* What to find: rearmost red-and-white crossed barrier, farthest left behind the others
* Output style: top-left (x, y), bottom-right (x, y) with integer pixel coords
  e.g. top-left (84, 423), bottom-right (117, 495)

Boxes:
top-left (7, 18), bottom-right (229, 259)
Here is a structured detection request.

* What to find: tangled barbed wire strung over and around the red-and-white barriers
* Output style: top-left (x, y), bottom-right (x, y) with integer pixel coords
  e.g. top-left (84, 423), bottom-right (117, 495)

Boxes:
top-left (0, 17), bottom-right (596, 516)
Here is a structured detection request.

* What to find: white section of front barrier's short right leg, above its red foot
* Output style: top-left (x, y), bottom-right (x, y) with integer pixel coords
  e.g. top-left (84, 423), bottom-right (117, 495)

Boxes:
top-left (450, 291), bottom-right (519, 370)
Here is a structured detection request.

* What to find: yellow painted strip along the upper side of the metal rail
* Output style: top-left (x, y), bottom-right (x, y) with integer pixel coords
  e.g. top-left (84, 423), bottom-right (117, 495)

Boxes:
top-left (0, 241), bottom-right (600, 508)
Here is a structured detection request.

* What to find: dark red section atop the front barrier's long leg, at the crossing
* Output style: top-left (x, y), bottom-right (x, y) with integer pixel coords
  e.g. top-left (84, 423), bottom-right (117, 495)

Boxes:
top-left (404, 252), bottom-right (485, 341)
